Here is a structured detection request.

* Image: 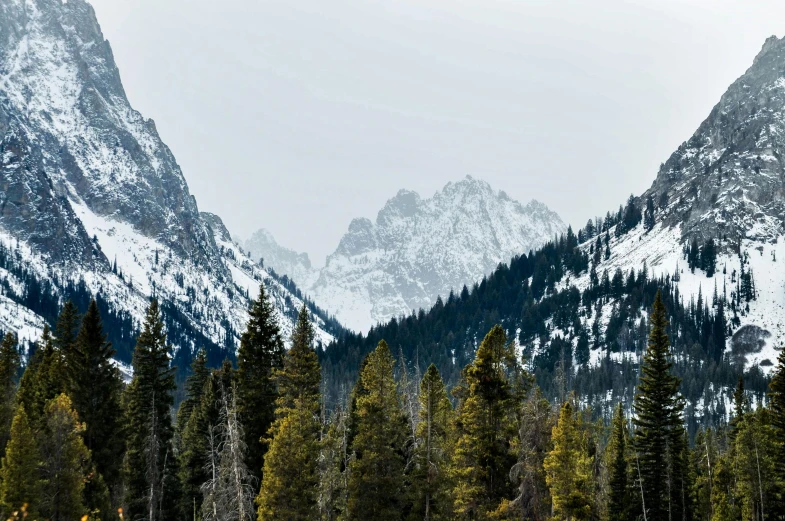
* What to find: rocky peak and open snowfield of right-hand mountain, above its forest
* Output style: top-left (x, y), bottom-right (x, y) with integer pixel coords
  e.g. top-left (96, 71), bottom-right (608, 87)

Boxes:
top-left (572, 36), bottom-right (785, 371)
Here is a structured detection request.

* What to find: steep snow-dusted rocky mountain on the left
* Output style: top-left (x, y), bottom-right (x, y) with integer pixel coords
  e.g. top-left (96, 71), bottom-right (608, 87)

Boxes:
top-left (0, 0), bottom-right (339, 367)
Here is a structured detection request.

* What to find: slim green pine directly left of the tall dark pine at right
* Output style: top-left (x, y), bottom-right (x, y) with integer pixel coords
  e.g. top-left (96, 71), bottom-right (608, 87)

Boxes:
top-left (608, 403), bottom-right (635, 521)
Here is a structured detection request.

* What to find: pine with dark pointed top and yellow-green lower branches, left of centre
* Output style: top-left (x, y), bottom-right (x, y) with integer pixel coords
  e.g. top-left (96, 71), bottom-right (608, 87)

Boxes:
top-left (256, 305), bottom-right (321, 521)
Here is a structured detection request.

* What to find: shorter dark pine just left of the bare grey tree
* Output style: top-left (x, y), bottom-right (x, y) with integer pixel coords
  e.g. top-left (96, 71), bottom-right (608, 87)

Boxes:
top-left (177, 349), bottom-right (214, 519)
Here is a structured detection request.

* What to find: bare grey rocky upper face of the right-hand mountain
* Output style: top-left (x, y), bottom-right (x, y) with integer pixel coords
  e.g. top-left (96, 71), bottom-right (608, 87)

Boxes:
top-left (647, 36), bottom-right (785, 242)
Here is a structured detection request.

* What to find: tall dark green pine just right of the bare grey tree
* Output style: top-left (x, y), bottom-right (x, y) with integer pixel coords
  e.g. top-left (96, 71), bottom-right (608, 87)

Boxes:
top-left (237, 284), bottom-right (284, 481)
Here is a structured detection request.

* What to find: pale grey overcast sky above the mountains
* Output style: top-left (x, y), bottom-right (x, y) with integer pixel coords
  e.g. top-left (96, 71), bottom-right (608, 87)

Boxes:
top-left (87, 0), bottom-right (785, 264)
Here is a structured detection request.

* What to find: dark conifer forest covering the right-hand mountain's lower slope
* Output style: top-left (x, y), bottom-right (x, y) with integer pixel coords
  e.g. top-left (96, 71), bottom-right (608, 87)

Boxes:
top-left (320, 219), bottom-right (773, 439)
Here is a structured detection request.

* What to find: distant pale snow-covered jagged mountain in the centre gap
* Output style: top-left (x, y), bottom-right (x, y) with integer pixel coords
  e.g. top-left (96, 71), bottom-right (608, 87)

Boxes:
top-left (245, 177), bottom-right (566, 331)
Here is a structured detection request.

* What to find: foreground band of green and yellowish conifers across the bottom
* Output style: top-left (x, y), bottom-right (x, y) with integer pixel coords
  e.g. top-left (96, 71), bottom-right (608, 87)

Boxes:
top-left (0, 288), bottom-right (785, 521)
